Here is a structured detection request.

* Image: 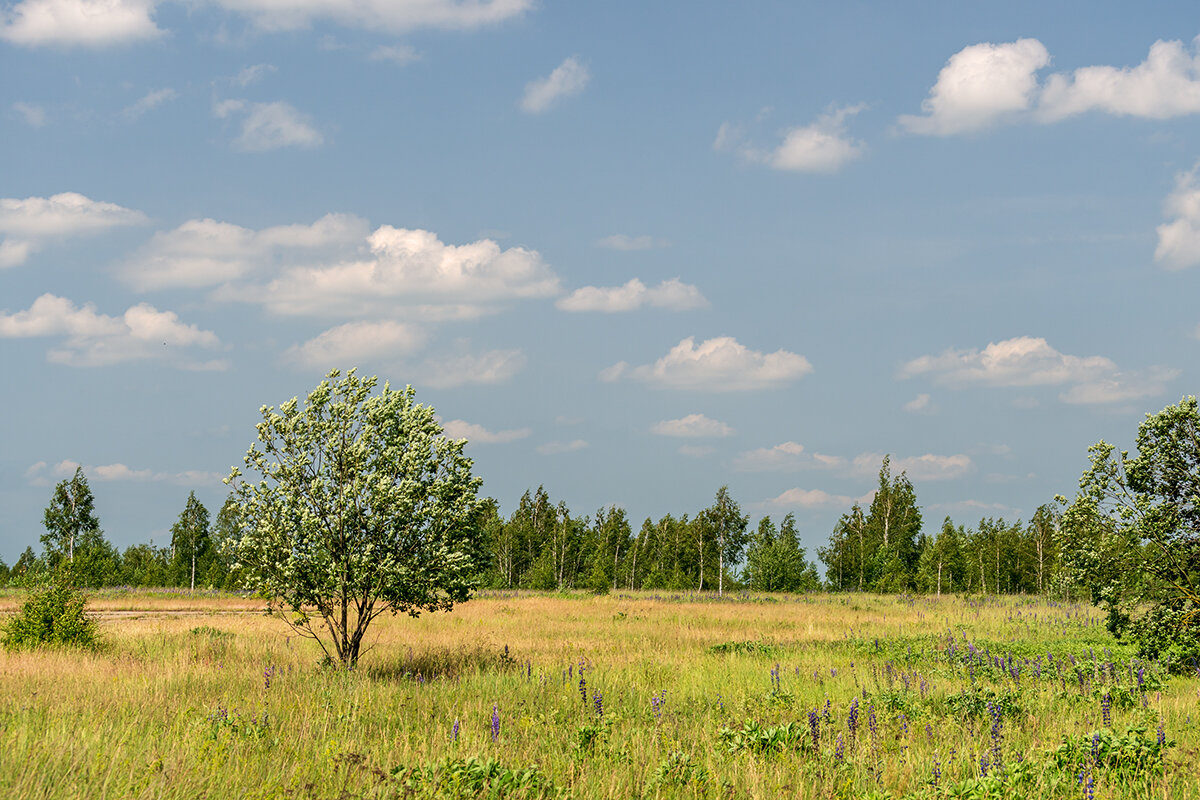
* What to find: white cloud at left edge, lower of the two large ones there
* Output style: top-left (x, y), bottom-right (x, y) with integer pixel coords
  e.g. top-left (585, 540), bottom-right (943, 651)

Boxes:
top-left (0, 294), bottom-right (226, 369)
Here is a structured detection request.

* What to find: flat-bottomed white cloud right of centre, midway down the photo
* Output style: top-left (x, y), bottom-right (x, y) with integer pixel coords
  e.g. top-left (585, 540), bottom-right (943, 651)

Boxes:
top-left (600, 336), bottom-right (812, 392)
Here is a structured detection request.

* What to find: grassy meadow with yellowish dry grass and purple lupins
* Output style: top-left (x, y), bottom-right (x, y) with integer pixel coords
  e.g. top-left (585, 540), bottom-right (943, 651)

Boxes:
top-left (0, 593), bottom-right (1200, 800)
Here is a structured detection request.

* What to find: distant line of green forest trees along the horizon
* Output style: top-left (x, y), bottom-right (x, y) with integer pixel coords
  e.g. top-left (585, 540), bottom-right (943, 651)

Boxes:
top-left (0, 458), bottom-right (1070, 596)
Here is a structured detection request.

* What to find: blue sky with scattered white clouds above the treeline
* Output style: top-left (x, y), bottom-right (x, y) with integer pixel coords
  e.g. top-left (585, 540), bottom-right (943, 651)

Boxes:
top-left (0, 0), bottom-right (1200, 564)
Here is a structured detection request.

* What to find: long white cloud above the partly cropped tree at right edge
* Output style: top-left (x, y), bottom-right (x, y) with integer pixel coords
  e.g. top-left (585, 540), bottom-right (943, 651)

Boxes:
top-left (900, 336), bottom-right (1180, 403)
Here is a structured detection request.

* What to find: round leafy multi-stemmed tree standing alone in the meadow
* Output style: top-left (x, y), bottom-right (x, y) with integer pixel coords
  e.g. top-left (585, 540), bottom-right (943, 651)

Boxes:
top-left (226, 369), bottom-right (482, 667)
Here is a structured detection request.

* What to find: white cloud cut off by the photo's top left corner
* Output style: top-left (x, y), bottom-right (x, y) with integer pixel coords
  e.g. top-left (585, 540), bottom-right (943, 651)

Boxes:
top-left (0, 0), bottom-right (162, 47)
